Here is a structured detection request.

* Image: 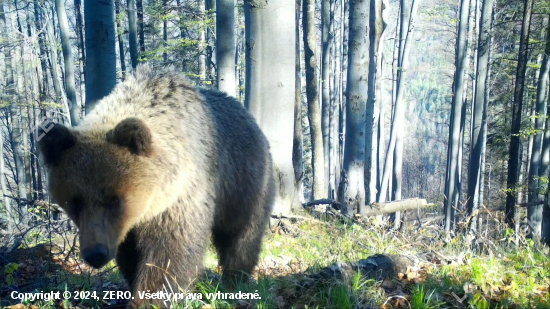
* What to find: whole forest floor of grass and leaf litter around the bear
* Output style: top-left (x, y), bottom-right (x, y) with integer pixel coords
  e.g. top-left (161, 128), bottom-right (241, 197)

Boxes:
top-left (0, 205), bottom-right (550, 309)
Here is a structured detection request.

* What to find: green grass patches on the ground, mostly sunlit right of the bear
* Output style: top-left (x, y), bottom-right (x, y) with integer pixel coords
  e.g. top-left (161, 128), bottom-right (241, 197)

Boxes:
top-left (1, 213), bottom-right (550, 309)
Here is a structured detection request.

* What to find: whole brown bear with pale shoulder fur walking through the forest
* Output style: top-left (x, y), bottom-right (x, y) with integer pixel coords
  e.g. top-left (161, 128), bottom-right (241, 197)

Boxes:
top-left (37, 66), bottom-right (275, 307)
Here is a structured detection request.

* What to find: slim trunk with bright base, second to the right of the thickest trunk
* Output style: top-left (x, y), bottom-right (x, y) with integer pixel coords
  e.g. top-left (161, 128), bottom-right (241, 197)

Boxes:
top-left (302, 0), bottom-right (327, 199)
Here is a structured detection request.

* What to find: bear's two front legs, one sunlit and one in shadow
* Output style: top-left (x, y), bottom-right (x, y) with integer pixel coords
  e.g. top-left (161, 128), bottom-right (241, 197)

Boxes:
top-left (117, 207), bottom-right (209, 308)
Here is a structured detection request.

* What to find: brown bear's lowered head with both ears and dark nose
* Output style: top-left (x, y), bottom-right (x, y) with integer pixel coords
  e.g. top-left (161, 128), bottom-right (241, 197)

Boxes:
top-left (37, 118), bottom-right (156, 268)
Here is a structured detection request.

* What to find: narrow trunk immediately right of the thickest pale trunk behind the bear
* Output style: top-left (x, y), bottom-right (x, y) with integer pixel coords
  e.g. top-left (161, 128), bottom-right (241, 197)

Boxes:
top-left (292, 0), bottom-right (304, 202)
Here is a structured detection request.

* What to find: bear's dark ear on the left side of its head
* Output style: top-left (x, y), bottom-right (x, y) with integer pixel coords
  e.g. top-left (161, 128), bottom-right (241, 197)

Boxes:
top-left (36, 123), bottom-right (76, 165)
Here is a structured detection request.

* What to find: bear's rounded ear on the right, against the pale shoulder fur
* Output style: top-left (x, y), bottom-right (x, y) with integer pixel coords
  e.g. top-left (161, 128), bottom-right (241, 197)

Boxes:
top-left (107, 117), bottom-right (153, 156)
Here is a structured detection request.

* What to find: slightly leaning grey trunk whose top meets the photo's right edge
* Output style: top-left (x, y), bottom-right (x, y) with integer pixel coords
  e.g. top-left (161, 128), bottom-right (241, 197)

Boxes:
top-left (527, 15), bottom-right (550, 238)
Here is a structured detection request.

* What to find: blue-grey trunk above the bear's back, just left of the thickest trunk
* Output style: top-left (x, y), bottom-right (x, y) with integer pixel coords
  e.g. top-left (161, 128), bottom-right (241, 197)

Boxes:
top-left (216, 0), bottom-right (236, 96)
